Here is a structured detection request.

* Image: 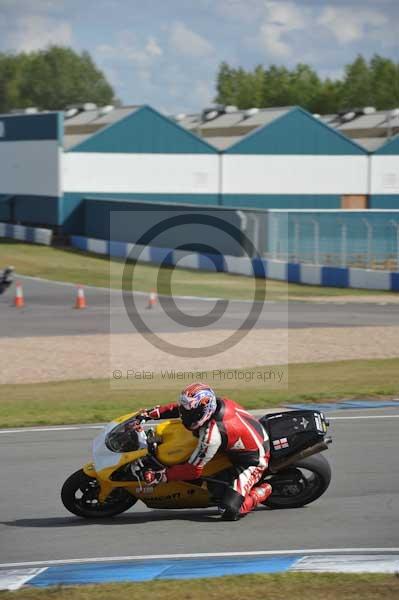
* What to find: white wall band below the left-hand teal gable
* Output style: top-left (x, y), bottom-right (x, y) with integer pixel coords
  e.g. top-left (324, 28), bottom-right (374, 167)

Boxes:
top-left (62, 152), bottom-right (219, 194)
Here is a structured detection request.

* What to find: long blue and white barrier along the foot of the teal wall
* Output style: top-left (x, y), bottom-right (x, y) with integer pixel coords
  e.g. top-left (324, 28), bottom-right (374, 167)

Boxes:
top-left (71, 236), bottom-right (399, 292)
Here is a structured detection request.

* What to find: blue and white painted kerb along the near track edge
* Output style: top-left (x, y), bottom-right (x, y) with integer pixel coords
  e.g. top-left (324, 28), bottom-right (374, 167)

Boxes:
top-left (0, 548), bottom-right (399, 590)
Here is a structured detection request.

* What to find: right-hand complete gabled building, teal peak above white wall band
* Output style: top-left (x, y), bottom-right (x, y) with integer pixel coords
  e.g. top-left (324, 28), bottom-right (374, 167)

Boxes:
top-left (222, 107), bottom-right (368, 210)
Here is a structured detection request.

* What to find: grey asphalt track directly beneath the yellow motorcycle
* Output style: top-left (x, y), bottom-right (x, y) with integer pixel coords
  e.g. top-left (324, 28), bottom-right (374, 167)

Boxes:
top-left (0, 409), bottom-right (399, 563)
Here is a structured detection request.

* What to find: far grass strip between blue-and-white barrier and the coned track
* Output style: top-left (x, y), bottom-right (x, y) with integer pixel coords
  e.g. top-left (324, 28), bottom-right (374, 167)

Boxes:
top-left (0, 240), bottom-right (394, 300)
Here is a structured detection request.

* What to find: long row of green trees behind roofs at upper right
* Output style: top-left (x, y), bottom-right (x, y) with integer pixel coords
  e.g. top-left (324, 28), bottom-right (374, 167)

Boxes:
top-left (215, 54), bottom-right (399, 114)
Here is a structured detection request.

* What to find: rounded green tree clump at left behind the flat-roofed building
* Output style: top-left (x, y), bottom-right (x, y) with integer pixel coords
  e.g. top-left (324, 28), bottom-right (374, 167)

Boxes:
top-left (0, 46), bottom-right (114, 113)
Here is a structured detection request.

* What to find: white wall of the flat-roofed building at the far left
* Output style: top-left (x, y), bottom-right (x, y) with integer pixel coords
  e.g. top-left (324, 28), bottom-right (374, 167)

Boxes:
top-left (0, 140), bottom-right (60, 196)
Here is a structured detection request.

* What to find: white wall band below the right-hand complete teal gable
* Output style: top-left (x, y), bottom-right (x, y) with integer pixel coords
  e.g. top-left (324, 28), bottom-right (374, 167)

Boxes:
top-left (222, 154), bottom-right (368, 194)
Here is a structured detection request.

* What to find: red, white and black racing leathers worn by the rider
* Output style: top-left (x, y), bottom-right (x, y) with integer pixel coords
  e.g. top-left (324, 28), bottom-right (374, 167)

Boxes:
top-left (148, 398), bottom-right (271, 514)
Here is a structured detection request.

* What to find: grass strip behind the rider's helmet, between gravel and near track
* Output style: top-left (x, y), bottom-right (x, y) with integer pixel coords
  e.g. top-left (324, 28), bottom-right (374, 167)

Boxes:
top-left (0, 358), bottom-right (399, 427)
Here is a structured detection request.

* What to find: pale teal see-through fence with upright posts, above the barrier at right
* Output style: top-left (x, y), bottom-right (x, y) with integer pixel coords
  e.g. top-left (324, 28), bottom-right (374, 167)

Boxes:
top-left (266, 210), bottom-right (399, 271)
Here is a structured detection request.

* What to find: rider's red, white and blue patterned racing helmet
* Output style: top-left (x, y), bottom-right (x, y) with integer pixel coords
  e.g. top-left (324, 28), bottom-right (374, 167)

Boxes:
top-left (179, 383), bottom-right (217, 430)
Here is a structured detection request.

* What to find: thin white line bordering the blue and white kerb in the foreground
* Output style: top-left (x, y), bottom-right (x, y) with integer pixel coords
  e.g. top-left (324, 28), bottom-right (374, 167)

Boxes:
top-left (0, 548), bottom-right (399, 569)
